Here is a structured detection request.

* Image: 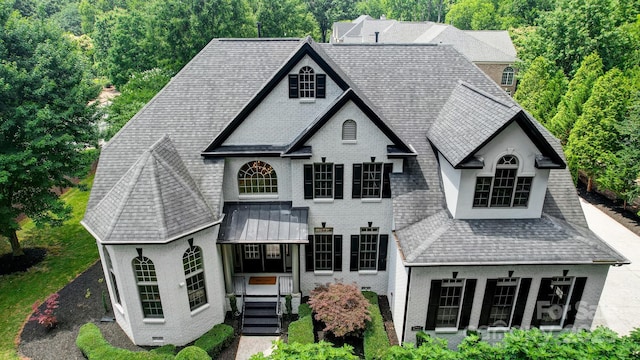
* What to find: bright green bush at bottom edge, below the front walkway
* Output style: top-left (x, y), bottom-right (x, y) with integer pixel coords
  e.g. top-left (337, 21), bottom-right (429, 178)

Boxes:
top-left (250, 340), bottom-right (358, 360)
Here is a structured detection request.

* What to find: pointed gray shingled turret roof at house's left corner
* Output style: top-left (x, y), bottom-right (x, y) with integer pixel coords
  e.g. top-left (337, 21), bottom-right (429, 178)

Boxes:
top-left (83, 136), bottom-right (216, 243)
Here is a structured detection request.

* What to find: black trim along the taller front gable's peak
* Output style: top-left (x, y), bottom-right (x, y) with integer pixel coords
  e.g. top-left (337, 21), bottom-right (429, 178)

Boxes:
top-left (202, 37), bottom-right (350, 155)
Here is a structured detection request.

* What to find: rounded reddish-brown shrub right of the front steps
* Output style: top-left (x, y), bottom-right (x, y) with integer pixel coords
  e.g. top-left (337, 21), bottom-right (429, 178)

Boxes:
top-left (309, 283), bottom-right (371, 337)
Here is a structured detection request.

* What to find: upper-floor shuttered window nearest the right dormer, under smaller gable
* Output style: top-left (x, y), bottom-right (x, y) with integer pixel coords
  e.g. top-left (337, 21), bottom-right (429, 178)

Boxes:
top-left (351, 162), bottom-right (393, 199)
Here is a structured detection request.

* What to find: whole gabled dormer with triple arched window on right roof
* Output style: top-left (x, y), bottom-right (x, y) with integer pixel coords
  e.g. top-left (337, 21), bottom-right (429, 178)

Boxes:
top-left (428, 83), bottom-right (565, 219)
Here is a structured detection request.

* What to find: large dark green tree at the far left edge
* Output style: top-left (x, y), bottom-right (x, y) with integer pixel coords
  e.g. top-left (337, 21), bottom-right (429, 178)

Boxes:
top-left (0, 12), bottom-right (98, 256)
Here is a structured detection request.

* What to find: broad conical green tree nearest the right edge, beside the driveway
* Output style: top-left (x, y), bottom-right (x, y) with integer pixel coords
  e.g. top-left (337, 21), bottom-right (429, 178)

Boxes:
top-left (565, 69), bottom-right (630, 191)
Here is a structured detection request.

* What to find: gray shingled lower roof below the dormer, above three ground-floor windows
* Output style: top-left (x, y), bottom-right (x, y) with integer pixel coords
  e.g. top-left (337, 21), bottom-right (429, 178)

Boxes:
top-left (397, 210), bottom-right (623, 266)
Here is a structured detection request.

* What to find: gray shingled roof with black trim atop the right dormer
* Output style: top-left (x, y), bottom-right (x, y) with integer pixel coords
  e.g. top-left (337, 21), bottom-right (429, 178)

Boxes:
top-left (427, 82), bottom-right (566, 169)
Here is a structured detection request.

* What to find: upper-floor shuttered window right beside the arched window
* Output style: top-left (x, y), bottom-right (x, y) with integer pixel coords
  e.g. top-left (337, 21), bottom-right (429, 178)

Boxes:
top-left (304, 163), bottom-right (344, 199)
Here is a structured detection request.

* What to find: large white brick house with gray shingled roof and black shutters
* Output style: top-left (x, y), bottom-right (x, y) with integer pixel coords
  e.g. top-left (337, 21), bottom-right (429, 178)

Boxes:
top-left (83, 39), bottom-right (627, 345)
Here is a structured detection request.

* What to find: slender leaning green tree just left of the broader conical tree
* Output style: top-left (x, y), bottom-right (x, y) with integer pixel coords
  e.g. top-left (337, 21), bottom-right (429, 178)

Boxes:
top-left (547, 53), bottom-right (604, 145)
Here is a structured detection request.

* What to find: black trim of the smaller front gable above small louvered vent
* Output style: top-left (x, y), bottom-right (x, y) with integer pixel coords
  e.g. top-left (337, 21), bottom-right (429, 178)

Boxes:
top-left (283, 89), bottom-right (416, 156)
